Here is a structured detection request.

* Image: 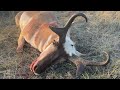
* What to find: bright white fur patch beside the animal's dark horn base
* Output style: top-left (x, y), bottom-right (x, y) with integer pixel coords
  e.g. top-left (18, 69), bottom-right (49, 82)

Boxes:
top-left (63, 35), bottom-right (81, 56)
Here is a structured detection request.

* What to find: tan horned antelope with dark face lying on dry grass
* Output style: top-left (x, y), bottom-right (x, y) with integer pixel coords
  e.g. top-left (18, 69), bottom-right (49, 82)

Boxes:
top-left (15, 11), bottom-right (109, 75)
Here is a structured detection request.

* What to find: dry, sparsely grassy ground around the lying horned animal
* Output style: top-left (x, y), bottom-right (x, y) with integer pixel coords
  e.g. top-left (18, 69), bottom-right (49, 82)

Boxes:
top-left (0, 11), bottom-right (120, 79)
